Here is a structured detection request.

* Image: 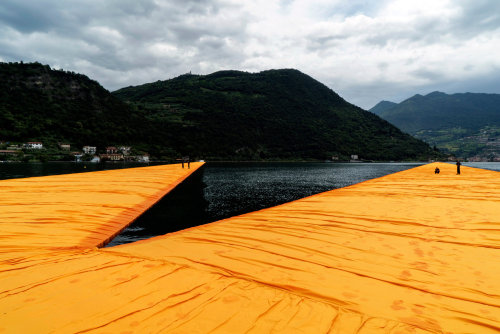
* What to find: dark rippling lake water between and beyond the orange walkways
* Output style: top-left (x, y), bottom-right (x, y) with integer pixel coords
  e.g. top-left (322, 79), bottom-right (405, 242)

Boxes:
top-left (0, 163), bottom-right (500, 246)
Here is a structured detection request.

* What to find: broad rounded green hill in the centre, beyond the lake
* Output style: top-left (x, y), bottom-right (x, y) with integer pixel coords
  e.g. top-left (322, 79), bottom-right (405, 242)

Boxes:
top-left (113, 70), bottom-right (432, 160)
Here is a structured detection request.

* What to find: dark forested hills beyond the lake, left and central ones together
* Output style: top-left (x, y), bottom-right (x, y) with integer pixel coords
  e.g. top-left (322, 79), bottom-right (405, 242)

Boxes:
top-left (0, 63), bottom-right (436, 160)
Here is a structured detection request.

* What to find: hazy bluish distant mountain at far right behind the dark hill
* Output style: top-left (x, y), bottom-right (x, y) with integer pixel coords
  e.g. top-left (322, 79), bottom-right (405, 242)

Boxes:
top-left (370, 92), bottom-right (500, 160)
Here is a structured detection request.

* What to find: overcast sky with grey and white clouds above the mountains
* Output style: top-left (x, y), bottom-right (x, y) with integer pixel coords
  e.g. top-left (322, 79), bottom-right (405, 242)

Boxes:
top-left (0, 0), bottom-right (500, 109)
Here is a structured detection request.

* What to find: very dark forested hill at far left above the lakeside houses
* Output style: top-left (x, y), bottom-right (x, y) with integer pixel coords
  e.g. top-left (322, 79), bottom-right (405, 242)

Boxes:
top-left (0, 63), bottom-right (143, 147)
